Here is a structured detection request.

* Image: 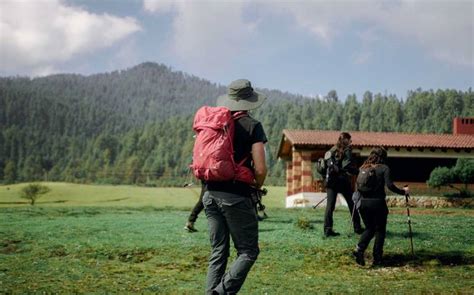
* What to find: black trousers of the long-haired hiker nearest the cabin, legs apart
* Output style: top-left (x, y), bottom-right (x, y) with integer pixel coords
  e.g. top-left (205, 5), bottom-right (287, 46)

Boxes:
top-left (324, 179), bottom-right (361, 233)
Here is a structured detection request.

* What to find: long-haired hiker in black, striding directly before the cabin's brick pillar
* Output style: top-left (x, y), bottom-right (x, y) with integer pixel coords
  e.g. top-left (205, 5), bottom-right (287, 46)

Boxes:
top-left (324, 132), bottom-right (363, 237)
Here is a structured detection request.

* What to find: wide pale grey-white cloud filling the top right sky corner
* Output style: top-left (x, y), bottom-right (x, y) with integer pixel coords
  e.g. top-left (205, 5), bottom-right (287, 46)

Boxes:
top-left (268, 0), bottom-right (474, 67)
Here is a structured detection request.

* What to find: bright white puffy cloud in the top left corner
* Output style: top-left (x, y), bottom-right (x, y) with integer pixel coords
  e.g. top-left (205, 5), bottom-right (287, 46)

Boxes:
top-left (0, 0), bottom-right (141, 75)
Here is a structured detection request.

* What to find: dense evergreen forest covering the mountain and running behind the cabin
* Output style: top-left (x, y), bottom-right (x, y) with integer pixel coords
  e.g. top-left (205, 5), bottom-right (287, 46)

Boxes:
top-left (0, 63), bottom-right (474, 186)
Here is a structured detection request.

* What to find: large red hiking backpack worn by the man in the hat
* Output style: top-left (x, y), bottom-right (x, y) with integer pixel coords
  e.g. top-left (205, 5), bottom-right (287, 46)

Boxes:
top-left (190, 106), bottom-right (255, 184)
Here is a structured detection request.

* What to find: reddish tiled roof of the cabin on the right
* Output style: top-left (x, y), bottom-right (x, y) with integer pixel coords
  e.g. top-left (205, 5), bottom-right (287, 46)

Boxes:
top-left (279, 129), bottom-right (474, 153)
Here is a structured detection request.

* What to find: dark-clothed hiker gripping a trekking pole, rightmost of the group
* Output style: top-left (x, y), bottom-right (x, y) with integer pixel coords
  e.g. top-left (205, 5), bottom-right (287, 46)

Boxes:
top-left (353, 147), bottom-right (409, 266)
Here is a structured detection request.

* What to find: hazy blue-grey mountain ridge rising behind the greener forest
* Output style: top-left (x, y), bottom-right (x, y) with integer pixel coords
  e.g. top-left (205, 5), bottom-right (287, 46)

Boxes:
top-left (0, 62), bottom-right (308, 135)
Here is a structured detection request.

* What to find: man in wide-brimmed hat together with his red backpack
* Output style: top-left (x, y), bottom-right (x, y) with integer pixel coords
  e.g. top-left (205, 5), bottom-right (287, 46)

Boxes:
top-left (192, 79), bottom-right (267, 294)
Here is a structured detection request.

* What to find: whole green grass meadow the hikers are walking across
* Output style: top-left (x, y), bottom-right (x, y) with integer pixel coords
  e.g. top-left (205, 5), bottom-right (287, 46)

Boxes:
top-left (0, 183), bottom-right (474, 294)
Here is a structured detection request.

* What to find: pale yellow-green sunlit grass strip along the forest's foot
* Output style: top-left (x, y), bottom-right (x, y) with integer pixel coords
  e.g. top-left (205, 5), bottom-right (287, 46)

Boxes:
top-left (0, 182), bottom-right (286, 208)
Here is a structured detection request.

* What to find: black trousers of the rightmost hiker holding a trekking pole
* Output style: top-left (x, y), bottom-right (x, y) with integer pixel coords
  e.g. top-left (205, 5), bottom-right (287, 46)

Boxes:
top-left (357, 203), bottom-right (388, 262)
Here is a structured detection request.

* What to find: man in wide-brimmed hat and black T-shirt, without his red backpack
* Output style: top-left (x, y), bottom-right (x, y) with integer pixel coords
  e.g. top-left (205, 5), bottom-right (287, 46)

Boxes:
top-left (203, 79), bottom-right (267, 294)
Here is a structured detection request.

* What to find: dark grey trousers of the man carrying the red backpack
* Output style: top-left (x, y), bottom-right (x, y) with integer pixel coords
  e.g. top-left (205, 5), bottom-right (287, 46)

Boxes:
top-left (203, 191), bottom-right (260, 294)
